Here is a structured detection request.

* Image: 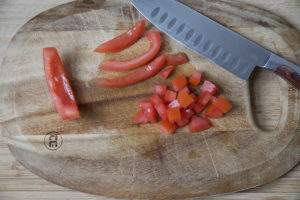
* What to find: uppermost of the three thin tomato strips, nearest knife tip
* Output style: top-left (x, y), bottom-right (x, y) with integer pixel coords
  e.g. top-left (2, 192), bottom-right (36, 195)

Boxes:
top-left (94, 20), bottom-right (146, 53)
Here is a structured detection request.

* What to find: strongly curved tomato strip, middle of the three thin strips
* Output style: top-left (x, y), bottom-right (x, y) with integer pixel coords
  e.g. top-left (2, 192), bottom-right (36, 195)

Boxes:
top-left (99, 31), bottom-right (161, 71)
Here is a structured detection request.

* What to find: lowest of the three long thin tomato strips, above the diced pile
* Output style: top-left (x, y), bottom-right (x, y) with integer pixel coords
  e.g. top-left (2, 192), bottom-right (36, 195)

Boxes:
top-left (98, 55), bottom-right (166, 87)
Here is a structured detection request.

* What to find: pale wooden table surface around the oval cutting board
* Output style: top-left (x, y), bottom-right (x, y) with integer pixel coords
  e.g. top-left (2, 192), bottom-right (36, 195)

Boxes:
top-left (0, 0), bottom-right (300, 200)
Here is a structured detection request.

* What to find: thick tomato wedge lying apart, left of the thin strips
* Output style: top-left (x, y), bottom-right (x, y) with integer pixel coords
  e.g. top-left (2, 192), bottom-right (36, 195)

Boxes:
top-left (43, 47), bottom-right (80, 120)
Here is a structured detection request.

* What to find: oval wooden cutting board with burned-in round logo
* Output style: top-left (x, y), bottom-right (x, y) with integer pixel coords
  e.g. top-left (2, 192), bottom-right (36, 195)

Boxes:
top-left (0, 0), bottom-right (300, 199)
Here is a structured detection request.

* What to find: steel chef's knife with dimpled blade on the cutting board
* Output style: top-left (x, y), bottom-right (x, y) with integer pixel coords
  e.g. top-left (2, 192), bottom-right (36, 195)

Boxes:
top-left (130, 0), bottom-right (300, 89)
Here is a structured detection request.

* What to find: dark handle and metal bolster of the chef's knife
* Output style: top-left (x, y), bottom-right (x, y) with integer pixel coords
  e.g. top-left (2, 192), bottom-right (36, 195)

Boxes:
top-left (264, 53), bottom-right (300, 89)
